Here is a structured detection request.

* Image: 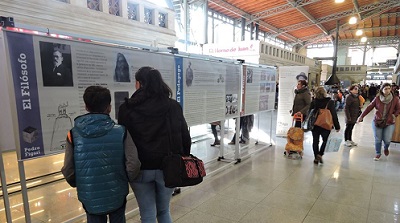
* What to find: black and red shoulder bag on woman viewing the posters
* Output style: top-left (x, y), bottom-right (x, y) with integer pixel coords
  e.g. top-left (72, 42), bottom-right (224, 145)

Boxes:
top-left (161, 112), bottom-right (206, 188)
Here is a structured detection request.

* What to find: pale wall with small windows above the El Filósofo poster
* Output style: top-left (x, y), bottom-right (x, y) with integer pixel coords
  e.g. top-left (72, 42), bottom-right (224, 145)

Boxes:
top-left (0, 0), bottom-right (177, 47)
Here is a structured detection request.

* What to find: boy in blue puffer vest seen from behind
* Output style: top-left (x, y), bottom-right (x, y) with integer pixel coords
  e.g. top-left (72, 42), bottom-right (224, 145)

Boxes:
top-left (61, 86), bottom-right (140, 223)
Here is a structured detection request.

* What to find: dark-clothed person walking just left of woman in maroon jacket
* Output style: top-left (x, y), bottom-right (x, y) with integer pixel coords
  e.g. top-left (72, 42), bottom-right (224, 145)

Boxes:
top-left (344, 85), bottom-right (361, 147)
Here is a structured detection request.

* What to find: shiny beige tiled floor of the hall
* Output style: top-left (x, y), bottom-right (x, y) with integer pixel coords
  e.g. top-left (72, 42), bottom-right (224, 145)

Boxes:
top-left (0, 109), bottom-right (400, 223)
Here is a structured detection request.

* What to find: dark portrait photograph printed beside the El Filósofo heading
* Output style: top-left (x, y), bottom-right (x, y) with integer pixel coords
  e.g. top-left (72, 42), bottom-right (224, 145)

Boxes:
top-left (39, 42), bottom-right (74, 87)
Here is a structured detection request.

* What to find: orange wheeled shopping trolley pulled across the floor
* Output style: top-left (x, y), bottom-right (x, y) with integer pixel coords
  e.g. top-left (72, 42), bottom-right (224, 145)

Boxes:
top-left (284, 114), bottom-right (304, 159)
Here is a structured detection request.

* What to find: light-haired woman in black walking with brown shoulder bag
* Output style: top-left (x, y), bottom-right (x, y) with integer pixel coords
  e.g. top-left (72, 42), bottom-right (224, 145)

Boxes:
top-left (310, 86), bottom-right (340, 164)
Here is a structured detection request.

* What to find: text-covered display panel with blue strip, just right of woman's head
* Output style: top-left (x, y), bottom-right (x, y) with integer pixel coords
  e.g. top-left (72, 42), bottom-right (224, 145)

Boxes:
top-left (180, 58), bottom-right (227, 126)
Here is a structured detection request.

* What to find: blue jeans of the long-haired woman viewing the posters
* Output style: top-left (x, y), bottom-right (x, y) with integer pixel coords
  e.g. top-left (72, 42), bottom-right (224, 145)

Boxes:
top-left (131, 170), bottom-right (174, 223)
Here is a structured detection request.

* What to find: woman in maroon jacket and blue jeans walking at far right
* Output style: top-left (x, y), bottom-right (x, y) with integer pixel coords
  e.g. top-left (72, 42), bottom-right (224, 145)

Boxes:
top-left (358, 83), bottom-right (400, 161)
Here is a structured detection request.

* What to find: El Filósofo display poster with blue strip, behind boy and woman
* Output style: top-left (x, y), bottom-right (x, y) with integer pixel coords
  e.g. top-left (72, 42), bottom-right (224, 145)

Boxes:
top-left (3, 32), bottom-right (175, 159)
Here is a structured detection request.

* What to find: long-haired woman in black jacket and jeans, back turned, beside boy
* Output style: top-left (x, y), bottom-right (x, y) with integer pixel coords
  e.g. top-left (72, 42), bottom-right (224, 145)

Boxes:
top-left (118, 67), bottom-right (191, 223)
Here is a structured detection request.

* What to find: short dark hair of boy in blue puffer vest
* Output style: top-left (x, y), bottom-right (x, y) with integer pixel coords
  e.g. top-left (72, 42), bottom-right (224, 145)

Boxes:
top-left (83, 86), bottom-right (111, 113)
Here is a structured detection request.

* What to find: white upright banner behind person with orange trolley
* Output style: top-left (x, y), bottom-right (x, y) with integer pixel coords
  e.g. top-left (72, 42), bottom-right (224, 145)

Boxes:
top-left (276, 66), bottom-right (309, 136)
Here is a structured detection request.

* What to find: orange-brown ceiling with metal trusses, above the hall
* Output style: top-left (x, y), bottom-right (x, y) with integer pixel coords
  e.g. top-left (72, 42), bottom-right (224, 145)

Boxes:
top-left (208, 0), bottom-right (400, 46)
